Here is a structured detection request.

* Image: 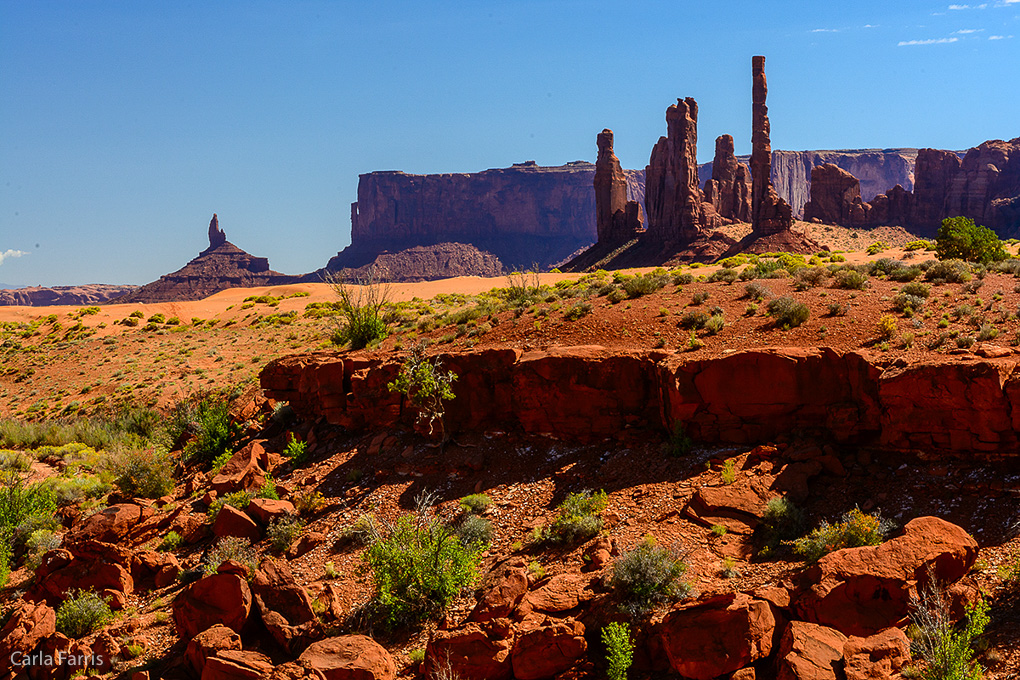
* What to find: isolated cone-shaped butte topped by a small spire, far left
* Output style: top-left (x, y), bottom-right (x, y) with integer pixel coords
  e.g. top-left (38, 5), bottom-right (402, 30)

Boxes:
top-left (109, 214), bottom-right (299, 304)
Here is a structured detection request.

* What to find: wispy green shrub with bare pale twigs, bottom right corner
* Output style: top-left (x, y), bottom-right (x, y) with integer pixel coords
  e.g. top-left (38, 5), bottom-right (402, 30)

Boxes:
top-left (910, 579), bottom-right (988, 680)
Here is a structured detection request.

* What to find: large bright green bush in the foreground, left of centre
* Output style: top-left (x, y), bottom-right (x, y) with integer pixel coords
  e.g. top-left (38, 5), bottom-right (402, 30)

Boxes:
top-left (364, 498), bottom-right (482, 627)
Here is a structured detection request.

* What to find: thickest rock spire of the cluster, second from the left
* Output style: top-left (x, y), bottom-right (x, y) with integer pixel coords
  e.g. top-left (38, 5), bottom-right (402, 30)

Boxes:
top-left (645, 97), bottom-right (708, 244)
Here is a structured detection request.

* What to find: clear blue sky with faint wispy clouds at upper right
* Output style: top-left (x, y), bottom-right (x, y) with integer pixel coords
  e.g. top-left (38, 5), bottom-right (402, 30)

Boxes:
top-left (0, 0), bottom-right (1020, 285)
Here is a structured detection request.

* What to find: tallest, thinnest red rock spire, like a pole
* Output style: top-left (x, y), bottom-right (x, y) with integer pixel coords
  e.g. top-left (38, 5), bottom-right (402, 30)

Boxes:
top-left (750, 56), bottom-right (794, 236)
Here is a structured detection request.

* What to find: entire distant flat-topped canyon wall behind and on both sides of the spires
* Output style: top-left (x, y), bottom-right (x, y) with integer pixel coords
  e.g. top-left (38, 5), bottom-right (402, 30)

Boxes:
top-left (338, 149), bottom-right (930, 270)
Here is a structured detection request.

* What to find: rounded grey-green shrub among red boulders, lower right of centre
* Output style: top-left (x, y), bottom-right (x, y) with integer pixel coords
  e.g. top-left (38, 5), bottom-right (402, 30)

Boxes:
top-left (611, 535), bottom-right (690, 616)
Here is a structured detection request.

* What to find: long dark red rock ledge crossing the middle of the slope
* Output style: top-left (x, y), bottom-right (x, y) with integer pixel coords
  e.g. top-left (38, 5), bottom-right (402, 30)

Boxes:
top-left (260, 347), bottom-right (1020, 457)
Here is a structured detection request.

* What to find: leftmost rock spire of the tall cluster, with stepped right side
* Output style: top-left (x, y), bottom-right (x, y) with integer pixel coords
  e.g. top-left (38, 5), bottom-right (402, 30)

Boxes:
top-left (594, 128), bottom-right (645, 244)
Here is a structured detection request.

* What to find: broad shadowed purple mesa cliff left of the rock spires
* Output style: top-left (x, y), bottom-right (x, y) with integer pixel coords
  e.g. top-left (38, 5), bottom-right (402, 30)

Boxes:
top-left (336, 161), bottom-right (645, 270)
